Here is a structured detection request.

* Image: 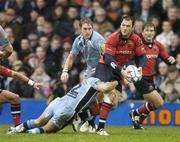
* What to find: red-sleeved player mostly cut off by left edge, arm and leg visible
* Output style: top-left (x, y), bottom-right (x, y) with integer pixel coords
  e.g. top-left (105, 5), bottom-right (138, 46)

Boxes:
top-left (0, 65), bottom-right (43, 126)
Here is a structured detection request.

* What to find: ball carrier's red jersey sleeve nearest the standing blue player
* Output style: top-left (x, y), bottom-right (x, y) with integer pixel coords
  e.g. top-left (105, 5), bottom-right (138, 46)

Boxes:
top-left (104, 32), bottom-right (119, 56)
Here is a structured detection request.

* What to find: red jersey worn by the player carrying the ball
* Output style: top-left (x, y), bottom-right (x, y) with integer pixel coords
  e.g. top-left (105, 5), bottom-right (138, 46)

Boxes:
top-left (99, 32), bottom-right (145, 67)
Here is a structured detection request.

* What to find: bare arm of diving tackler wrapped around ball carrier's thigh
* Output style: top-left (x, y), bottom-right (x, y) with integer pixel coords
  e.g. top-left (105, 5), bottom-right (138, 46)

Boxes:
top-left (97, 81), bottom-right (118, 92)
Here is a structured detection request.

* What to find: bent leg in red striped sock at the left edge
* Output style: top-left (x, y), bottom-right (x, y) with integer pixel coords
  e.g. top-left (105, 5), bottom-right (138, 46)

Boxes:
top-left (0, 90), bottom-right (21, 126)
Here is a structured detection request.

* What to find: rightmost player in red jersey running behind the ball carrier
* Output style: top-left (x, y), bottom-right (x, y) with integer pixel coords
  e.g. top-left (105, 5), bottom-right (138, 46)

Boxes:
top-left (129, 23), bottom-right (175, 129)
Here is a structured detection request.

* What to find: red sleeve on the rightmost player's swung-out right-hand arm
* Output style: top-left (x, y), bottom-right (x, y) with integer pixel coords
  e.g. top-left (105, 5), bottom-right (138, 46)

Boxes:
top-left (155, 41), bottom-right (169, 60)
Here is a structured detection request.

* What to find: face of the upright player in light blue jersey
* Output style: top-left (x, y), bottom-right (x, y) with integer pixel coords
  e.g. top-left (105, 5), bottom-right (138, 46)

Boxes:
top-left (81, 23), bottom-right (93, 39)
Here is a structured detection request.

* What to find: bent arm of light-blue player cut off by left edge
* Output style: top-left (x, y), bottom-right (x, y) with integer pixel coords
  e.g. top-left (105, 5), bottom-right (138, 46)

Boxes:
top-left (0, 26), bottom-right (13, 59)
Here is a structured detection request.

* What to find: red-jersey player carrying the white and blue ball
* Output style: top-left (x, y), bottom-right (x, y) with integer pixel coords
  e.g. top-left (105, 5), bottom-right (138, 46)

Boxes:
top-left (93, 16), bottom-right (147, 135)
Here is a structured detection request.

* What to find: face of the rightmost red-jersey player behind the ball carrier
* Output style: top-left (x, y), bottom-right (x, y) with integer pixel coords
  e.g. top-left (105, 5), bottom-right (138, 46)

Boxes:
top-left (142, 27), bottom-right (155, 42)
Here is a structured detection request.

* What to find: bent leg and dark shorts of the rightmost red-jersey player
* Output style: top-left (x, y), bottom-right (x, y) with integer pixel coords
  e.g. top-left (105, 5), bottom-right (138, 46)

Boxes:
top-left (129, 78), bottom-right (163, 129)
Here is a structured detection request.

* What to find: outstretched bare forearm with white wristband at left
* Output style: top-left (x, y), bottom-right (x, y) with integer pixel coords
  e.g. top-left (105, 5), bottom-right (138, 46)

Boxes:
top-left (11, 70), bottom-right (44, 89)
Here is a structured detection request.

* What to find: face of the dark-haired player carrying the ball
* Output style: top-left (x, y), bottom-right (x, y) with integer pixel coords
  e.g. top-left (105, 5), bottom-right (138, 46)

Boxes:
top-left (120, 19), bottom-right (133, 37)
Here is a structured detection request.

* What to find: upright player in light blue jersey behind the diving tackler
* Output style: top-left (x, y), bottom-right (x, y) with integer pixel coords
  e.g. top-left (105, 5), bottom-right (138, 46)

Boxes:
top-left (61, 18), bottom-right (105, 132)
